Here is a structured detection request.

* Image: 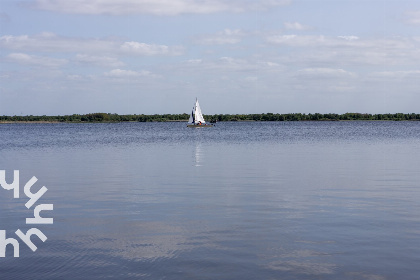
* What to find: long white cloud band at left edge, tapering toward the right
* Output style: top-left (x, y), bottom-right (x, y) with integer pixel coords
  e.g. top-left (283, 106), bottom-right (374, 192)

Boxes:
top-left (0, 33), bottom-right (183, 56)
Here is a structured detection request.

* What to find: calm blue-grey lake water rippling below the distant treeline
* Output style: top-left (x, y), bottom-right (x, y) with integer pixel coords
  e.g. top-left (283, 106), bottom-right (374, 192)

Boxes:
top-left (0, 122), bottom-right (420, 280)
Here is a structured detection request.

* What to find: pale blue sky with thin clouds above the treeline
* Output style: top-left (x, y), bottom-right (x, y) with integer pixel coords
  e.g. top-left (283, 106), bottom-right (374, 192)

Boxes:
top-left (0, 0), bottom-right (420, 115)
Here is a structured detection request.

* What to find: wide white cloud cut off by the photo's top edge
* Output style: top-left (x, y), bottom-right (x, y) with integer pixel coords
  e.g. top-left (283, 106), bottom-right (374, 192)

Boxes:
top-left (32, 0), bottom-right (290, 16)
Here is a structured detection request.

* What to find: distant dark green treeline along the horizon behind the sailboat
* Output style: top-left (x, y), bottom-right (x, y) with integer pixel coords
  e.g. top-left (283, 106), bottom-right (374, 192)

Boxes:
top-left (0, 113), bottom-right (420, 122)
